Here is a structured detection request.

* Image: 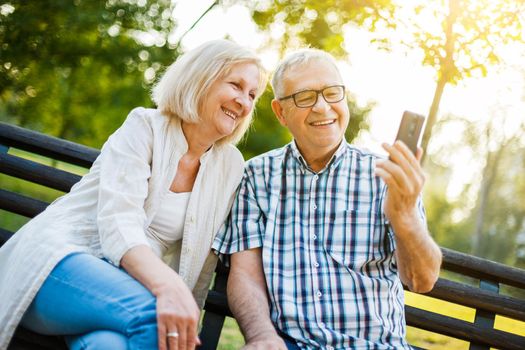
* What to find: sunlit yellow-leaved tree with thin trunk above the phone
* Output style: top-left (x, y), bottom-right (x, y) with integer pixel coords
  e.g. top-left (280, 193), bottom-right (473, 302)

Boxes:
top-left (405, 0), bottom-right (525, 158)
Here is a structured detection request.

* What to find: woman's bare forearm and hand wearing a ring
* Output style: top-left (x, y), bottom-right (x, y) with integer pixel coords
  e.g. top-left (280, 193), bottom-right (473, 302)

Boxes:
top-left (120, 245), bottom-right (200, 350)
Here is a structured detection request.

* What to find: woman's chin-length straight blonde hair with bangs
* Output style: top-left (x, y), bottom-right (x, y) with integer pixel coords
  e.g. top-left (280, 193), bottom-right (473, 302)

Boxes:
top-left (152, 40), bottom-right (267, 144)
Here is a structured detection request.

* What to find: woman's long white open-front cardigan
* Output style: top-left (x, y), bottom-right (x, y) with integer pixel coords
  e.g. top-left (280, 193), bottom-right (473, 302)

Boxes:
top-left (0, 108), bottom-right (244, 349)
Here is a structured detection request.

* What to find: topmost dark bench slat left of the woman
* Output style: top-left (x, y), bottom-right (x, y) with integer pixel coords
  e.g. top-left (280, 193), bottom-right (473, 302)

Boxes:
top-left (0, 122), bottom-right (100, 168)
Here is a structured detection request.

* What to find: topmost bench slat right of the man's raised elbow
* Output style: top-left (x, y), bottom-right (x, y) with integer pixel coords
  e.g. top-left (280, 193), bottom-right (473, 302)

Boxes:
top-left (441, 248), bottom-right (525, 289)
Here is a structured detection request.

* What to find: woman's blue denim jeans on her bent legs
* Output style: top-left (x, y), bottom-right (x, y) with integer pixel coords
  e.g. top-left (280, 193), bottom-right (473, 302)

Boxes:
top-left (21, 254), bottom-right (158, 350)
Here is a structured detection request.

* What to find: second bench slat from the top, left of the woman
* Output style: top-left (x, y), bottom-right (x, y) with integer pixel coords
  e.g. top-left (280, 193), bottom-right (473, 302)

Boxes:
top-left (0, 153), bottom-right (81, 192)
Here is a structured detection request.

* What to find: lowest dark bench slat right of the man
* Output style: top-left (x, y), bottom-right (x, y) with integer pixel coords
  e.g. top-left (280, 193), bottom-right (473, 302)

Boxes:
top-left (405, 306), bottom-right (525, 350)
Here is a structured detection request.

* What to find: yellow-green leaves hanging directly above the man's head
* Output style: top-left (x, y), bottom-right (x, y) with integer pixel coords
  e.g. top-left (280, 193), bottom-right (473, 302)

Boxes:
top-left (243, 0), bottom-right (395, 57)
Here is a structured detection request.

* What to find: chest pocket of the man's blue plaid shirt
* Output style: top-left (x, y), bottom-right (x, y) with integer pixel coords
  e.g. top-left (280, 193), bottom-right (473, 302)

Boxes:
top-left (324, 210), bottom-right (394, 275)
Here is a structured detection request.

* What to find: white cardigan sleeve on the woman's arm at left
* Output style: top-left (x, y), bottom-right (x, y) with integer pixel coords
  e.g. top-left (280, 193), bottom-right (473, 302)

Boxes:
top-left (97, 109), bottom-right (153, 266)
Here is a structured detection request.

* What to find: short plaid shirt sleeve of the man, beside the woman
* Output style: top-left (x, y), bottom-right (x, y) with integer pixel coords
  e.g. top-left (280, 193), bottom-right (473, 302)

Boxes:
top-left (212, 170), bottom-right (266, 263)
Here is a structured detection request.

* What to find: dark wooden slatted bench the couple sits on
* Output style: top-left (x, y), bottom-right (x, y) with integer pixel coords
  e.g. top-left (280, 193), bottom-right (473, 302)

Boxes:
top-left (0, 123), bottom-right (525, 350)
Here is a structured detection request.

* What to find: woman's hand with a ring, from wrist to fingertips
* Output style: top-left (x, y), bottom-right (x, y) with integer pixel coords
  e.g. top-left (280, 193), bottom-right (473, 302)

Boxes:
top-left (152, 273), bottom-right (200, 350)
